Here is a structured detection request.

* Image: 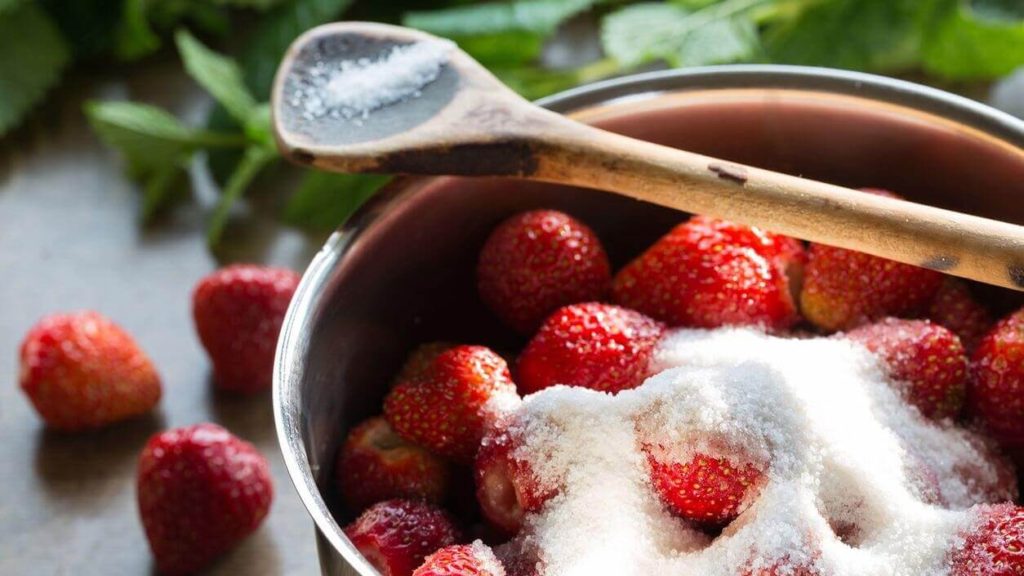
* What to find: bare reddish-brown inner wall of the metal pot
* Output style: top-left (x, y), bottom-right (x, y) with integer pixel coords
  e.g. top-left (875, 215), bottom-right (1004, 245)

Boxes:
top-left (288, 83), bottom-right (1024, 543)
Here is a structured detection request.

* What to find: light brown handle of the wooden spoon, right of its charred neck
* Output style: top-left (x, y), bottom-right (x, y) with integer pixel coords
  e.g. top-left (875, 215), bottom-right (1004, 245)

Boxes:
top-left (528, 114), bottom-right (1024, 291)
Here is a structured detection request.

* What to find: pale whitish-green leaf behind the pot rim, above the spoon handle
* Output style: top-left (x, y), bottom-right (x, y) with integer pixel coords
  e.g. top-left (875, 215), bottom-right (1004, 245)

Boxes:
top-left (601, 0), bottom-right (765, 68)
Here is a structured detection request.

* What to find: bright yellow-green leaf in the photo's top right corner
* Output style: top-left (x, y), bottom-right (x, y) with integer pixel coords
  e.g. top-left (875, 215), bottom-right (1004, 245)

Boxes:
top-left (923, 1), bottom-right (1024, 80)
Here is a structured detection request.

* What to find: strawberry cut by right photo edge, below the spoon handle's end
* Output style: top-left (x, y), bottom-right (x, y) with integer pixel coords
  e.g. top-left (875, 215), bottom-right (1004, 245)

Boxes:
top-left (968, 308), bottom-right (1024, 447)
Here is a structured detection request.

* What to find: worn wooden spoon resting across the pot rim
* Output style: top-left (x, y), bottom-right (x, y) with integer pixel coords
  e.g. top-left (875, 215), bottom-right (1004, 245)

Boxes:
top-left (272, 23), bottom-right (1024, 290)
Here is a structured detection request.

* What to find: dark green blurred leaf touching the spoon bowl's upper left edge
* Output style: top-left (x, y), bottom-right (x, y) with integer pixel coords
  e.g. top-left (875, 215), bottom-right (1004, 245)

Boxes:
top-left (239, 0), bottom-right (352, 99)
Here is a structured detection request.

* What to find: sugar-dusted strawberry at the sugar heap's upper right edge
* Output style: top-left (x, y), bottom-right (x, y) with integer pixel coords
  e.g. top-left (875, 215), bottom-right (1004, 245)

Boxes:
top-left (846, 318), bottom-right (967, 419)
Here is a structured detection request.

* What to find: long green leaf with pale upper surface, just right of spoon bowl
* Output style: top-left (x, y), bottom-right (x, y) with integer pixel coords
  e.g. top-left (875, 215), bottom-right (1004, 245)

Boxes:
top-left (402, 0), bottom-right (600, 66)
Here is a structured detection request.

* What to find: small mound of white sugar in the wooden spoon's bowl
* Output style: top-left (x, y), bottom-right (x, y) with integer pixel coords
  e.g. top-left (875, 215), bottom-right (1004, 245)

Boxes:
top-left (290, 40), bottom-right (455, 120)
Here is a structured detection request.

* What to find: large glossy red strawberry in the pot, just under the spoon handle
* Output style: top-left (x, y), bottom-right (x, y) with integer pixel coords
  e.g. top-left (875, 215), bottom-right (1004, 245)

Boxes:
top-left (611, 218), bottom-right (799, 330)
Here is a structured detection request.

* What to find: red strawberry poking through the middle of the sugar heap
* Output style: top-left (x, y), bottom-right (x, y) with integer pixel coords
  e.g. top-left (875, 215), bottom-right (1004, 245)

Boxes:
top-left (643, 444), bottom-right (764, 526)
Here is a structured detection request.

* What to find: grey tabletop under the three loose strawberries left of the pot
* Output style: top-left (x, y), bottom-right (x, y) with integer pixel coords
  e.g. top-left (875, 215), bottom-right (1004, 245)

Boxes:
top-left (0, 63), bottom-right (319, 576)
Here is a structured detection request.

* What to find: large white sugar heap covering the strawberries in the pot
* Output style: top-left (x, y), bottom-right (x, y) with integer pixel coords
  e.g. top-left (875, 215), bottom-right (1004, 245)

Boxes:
top-left (499, 329), bottom-right (1009, 576)
